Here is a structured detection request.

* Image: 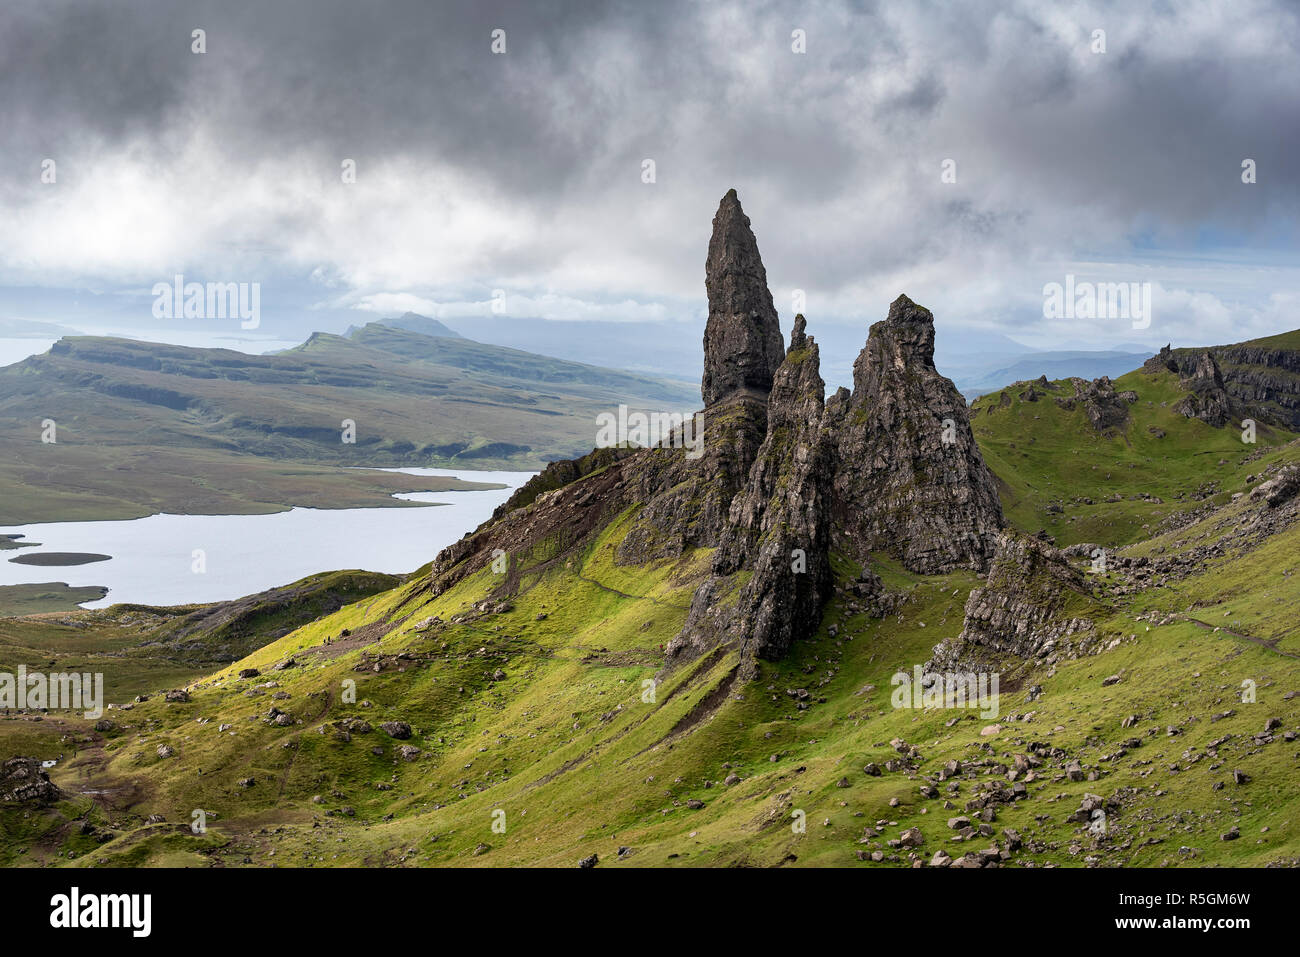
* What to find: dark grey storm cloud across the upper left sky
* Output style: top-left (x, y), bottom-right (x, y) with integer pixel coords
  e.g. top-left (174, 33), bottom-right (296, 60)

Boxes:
top-left (0, 0), bottom-right (710, 199)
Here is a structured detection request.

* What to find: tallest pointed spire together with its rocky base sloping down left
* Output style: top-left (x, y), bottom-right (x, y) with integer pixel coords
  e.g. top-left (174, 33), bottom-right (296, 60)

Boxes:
top-left (432, 190), bottom-right (785, 582)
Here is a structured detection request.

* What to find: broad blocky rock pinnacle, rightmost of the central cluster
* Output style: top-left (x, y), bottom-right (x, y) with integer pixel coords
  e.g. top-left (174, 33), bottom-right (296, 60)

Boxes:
top-left (827, 295), bottom-right (1002, 573)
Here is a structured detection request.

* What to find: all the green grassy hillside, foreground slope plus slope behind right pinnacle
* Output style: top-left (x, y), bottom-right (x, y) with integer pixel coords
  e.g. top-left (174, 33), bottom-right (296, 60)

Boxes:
top-left (0, 332), bottom-right (1300, 867)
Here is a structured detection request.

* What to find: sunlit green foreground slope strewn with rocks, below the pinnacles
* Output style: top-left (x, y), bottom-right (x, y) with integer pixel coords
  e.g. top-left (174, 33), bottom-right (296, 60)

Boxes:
top-left (0, 436), bottom-right (1300, 867)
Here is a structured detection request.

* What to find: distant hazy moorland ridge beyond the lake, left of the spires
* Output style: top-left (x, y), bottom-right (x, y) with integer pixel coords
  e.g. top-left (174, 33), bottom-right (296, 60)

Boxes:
top-left (0, 317), bottom-right (699, 521)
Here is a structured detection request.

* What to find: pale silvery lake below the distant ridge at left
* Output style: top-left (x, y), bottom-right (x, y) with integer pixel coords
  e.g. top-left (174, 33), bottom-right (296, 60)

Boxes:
top-left (0, 468), bottom-right (534, 609)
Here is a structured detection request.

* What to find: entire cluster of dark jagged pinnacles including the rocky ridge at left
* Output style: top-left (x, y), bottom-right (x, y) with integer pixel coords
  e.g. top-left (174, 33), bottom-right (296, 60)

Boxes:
top-left (430, 190), bottom-right (1002, 668)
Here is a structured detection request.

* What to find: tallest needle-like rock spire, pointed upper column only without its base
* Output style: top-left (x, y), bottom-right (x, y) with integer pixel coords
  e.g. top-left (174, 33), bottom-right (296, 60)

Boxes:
top-left (701, 190), bottom-right (785, 407)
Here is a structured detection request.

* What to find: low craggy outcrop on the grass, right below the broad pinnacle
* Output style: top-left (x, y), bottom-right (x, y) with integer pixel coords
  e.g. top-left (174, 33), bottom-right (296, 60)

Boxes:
top-left (927, 532), bottom-right (1101, 672)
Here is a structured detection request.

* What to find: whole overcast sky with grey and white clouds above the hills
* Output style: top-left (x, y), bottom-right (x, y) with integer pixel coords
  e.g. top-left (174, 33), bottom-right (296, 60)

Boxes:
top-left (0, 0), bottom-right (1300, 361)
